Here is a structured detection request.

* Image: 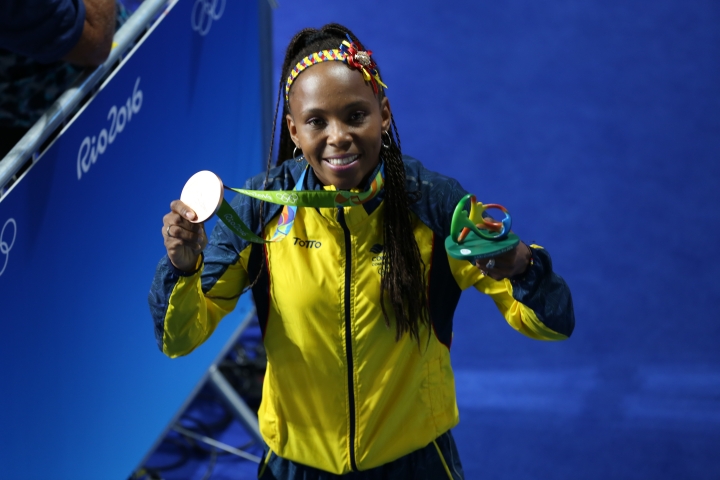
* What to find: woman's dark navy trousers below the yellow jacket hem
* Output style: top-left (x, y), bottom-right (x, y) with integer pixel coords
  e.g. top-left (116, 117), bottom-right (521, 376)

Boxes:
top-left (258, 431), bottom-right (465, 480)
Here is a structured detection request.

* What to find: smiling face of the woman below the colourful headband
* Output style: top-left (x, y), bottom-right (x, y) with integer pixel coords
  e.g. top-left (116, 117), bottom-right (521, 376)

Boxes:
top-left (286, 61), bottom-right (390, 190)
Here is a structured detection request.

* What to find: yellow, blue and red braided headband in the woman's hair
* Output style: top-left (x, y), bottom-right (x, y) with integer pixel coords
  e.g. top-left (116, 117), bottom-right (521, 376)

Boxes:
top-left (285, 35), bottom-right (387, 102)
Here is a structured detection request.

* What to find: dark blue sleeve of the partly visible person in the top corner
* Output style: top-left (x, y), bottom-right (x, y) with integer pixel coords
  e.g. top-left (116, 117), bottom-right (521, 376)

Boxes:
top-left (0, 0), bottom-right (85, 63)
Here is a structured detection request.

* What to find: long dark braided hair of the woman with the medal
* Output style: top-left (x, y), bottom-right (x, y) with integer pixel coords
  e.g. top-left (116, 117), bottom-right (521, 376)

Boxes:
top-left (262, 23), bottom-right (430, 341)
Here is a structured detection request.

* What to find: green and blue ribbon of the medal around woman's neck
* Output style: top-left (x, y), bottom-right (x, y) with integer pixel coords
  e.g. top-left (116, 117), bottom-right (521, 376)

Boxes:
top-left (217, 166), bottom-right (385, 243)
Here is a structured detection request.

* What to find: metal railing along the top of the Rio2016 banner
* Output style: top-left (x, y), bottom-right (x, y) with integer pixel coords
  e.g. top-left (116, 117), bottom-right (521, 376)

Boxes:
top-left (0, 0), bottom-right (177, 195)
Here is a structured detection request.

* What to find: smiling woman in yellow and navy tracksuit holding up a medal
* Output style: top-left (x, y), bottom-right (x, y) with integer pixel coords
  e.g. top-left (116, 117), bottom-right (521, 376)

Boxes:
top-left (150, 20), bottom-right (574, 480)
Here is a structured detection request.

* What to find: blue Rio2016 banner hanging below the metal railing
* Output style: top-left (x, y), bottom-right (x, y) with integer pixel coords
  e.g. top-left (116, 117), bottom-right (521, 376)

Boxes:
top-left (0, 0), bottom-right (265, 479)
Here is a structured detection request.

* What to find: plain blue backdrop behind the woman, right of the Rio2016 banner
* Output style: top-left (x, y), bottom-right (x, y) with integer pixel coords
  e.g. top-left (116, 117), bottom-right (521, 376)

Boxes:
top-left (274, 0), bottom-right (720, 479)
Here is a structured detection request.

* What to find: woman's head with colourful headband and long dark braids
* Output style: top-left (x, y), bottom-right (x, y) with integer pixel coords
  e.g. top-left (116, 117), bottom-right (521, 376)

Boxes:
top-left (268, 24), bottom-right (429, 346)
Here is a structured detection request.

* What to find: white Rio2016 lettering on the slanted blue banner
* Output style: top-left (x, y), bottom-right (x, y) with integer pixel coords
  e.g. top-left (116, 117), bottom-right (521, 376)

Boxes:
top-left (77, 77), bottom-right (142, 180)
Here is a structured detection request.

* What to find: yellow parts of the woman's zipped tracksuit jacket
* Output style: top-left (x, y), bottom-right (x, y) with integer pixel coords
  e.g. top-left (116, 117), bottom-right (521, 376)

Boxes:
top-left (163, 204), bottom-right (558, 474)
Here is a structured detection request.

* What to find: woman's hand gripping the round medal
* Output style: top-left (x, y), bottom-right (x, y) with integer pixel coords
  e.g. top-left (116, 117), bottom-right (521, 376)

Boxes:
top-left (162, 200), bottom-right (207, 272)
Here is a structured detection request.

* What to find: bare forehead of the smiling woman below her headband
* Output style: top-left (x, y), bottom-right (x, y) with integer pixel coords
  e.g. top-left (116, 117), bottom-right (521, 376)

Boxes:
top-left (289, 61), bottom-right (377, 110)
